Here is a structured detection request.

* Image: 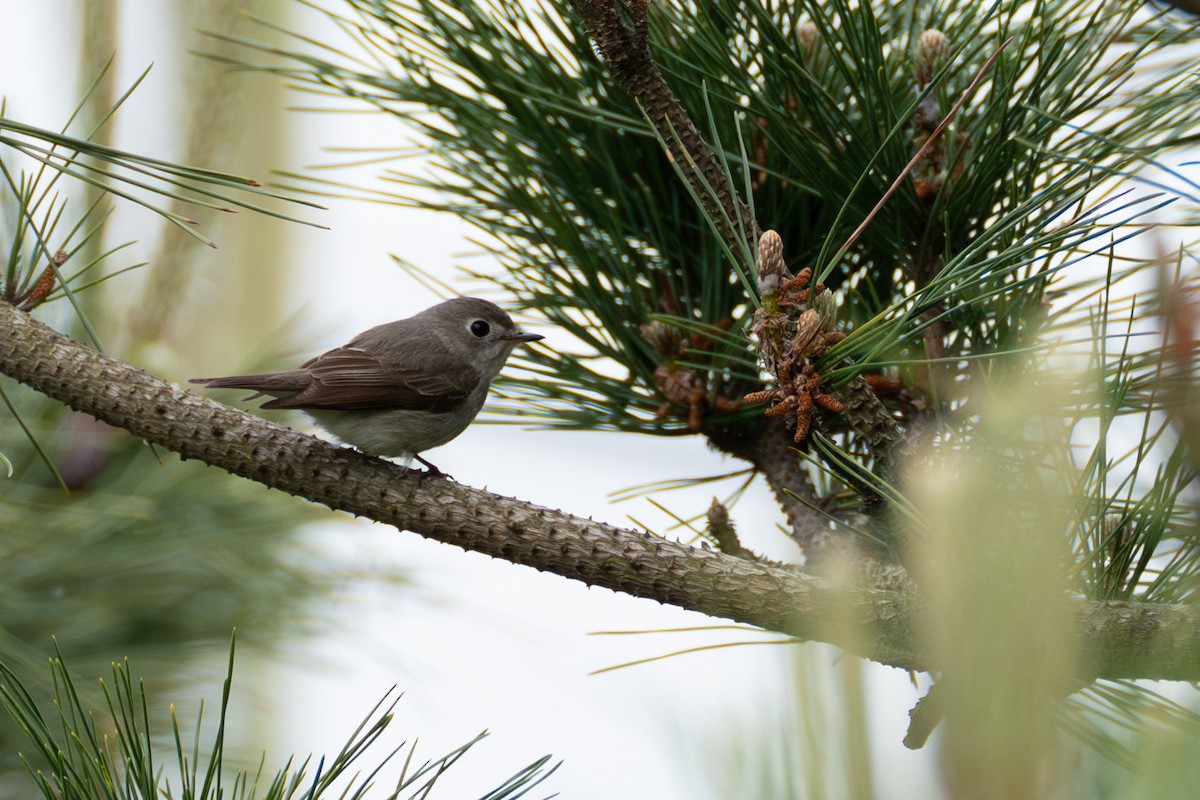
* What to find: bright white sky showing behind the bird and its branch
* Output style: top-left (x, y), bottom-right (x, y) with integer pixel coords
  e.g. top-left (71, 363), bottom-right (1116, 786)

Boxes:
top-left (0, 0), bottom-right (955, 800)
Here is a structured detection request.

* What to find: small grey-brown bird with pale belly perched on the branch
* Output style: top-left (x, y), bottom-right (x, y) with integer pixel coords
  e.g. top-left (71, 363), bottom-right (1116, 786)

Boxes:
top-left (191, 297), bottom-right (544, 475)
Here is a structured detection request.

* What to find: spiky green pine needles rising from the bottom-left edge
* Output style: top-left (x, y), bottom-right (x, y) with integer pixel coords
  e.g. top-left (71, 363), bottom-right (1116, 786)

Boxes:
top-left (0, 642), bottom-right (558, 800)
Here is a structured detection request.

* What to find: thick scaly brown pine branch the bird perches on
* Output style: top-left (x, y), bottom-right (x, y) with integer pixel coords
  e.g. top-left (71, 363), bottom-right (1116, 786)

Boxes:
top-left (7, 303), bottom-right (1200, 681)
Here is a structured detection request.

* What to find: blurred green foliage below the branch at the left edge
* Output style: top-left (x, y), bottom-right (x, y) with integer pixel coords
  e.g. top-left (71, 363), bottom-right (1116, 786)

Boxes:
top-left (0, 381), bottom-right (324, 662)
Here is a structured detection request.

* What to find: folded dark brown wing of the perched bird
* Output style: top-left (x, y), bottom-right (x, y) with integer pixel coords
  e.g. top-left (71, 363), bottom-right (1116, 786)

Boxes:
top-left (255, 347), bottom-right (479, 413)
